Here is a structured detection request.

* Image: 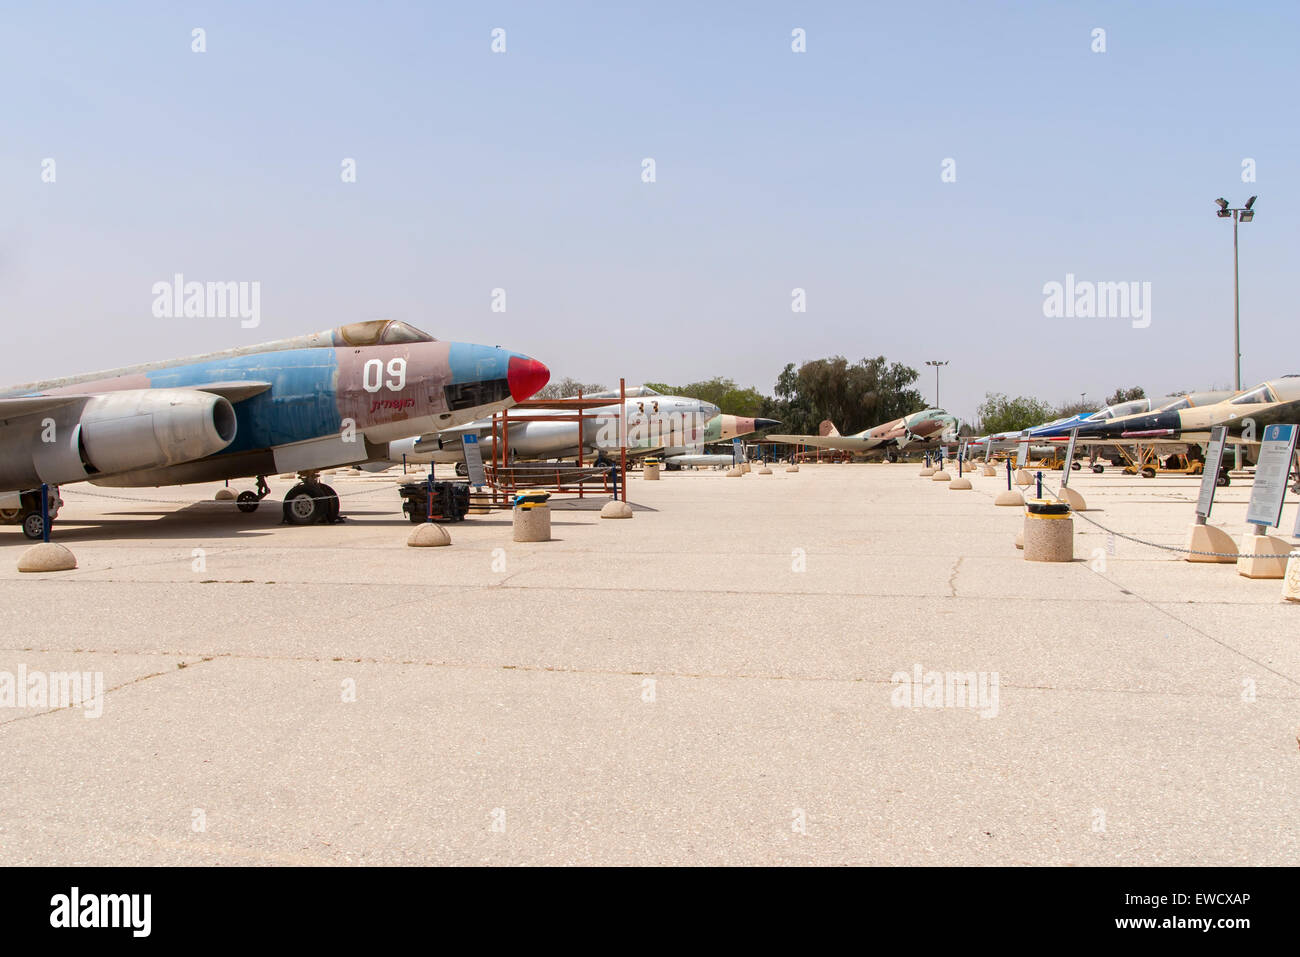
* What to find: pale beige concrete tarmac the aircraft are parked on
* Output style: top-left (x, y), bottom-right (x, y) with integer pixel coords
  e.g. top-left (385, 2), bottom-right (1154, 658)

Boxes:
top-left (0, 464), bottom-right (1300, 865)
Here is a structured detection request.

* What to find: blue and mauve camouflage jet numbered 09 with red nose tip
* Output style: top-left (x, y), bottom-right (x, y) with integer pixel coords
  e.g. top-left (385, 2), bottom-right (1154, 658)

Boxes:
top-left (0, 320), bottom-right (550, 537)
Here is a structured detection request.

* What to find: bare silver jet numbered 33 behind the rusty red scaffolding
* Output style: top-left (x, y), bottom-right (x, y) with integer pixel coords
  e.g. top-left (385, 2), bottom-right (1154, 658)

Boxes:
top-left (386, 386), bottom-right (720, 471)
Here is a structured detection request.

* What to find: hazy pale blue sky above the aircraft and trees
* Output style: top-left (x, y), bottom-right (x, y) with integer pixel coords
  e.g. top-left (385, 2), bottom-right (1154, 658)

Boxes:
top-left (0, 0), bottom-right (1300, 417)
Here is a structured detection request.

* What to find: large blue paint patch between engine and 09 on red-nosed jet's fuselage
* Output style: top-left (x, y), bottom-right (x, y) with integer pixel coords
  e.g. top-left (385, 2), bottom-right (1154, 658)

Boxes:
top-left (148, 348), bottom-right (342, 455)
